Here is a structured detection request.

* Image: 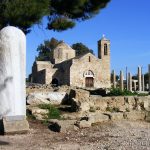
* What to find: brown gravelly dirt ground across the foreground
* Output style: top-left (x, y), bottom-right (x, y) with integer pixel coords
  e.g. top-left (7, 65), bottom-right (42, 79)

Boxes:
top-left (0, 121), bottom-right (150, 150)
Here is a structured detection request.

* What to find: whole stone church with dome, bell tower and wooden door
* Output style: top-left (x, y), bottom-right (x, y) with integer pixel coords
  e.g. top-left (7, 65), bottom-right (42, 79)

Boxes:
top-left (32, 37), bottom-right (110, 88)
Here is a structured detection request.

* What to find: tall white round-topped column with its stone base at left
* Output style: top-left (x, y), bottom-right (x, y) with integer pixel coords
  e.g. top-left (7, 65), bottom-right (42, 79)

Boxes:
top-left (0, 26), bottom-right (29, 134)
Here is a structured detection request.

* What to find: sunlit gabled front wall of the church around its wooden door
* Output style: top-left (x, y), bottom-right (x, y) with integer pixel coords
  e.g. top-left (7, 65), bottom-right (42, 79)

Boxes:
top-left (70, 53), bottom-right (110, 88)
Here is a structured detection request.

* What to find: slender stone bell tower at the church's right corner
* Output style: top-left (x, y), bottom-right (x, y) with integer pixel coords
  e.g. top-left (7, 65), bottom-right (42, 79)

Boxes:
top-left (98, 35), bottom-right (110, 85)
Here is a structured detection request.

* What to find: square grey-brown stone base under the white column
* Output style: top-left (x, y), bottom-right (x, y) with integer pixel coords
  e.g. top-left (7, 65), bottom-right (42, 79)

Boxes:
top-left (3, 116), bottom-right (29, 134)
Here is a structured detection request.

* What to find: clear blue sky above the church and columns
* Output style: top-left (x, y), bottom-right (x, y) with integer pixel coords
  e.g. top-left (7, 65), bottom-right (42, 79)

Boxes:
top-left (27, 0), bottom-right (150, 75)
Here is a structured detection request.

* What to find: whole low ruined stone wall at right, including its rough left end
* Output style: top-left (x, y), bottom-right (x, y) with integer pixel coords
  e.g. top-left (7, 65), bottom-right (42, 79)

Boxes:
top-left (70, 89), bottom-right (150, 121)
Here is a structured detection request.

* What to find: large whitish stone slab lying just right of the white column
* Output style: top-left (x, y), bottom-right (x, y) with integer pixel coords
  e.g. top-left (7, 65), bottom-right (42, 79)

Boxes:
top-left (27, 92), bottom-right (66, 105)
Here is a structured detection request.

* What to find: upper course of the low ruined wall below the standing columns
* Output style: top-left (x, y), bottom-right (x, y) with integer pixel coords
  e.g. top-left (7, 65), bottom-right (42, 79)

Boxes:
top-left (89, 95), bottom-right (150, 112)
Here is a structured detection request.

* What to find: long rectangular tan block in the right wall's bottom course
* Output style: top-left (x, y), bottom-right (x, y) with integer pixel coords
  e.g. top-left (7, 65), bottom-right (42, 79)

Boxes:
top-left (124, 111), bottom-right (145, 120)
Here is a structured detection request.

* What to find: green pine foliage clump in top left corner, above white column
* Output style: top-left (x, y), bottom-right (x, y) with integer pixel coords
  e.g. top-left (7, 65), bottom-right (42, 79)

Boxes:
top-left (0, 0), bottom-right (49, 33)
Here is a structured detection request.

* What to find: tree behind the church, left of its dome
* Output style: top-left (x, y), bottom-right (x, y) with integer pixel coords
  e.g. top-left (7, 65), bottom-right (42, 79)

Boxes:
top-left (36, 38), bottom-right (61, 61)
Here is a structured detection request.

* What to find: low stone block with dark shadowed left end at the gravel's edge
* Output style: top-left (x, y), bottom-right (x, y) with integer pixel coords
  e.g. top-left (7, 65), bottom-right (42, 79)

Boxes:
top-left (48, 119), bottom-right (76, 133)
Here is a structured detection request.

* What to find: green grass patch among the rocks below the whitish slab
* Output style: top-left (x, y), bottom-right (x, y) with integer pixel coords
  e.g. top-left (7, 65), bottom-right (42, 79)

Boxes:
top-left (38, 104), bottom-right (60, 119)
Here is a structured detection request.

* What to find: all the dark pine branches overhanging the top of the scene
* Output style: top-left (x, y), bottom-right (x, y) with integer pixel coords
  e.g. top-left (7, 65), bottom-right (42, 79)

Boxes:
top-left (0, 0), bottom-right (110, 33)
